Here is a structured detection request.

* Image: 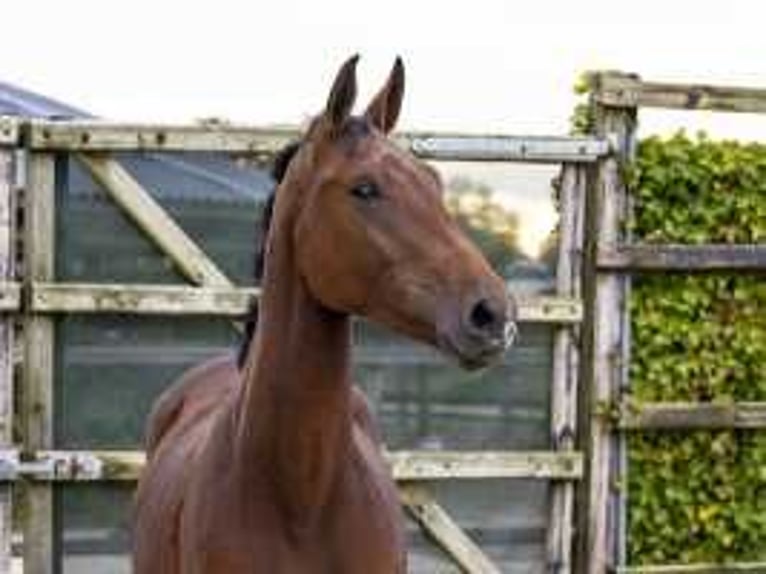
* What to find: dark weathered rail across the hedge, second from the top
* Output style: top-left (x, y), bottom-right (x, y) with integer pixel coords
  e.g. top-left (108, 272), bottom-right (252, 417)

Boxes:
top-left (598, 244), bottom-right (766, 272)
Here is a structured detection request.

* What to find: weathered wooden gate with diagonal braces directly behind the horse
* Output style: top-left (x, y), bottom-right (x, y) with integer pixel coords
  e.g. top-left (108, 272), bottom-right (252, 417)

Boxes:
top-left (0, 119), bottom-right (611, 574)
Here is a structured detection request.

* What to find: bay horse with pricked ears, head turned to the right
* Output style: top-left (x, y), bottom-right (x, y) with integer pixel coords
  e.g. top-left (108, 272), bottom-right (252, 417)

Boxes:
top-left (133, 56), bottom-right (515, 574)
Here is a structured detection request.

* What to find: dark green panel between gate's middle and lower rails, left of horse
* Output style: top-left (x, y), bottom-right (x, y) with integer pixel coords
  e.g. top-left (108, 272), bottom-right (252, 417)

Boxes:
top-left (55, 315), bottom-right (238, 449)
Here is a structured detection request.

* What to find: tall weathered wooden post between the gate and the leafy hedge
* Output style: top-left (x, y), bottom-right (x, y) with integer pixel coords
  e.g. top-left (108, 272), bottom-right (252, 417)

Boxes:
top-left (576, 73), bottom-right (637, 574)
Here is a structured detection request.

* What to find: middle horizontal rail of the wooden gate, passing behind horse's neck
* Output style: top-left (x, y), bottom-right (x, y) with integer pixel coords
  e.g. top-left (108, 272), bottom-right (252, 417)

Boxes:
top-left (30, 283), bottom-right (582, 323)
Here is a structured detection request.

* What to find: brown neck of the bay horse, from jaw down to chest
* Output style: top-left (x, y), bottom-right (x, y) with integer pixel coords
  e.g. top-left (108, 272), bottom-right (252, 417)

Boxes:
top-left (235, 205), bottom-right (351, 525)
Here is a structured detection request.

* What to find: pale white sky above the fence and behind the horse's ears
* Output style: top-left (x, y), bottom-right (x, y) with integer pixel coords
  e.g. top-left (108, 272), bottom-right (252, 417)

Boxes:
top-left (0, 0), bottom-right (766, 253)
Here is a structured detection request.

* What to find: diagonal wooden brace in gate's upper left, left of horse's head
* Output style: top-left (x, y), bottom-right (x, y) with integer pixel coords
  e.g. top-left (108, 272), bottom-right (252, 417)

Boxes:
top-left (78, 155), bottom-right (236, 287)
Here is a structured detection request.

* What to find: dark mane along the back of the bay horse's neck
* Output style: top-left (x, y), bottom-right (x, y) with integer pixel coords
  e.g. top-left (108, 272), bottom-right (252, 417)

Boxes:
top-left (237, 141), bottom-right (301, 369)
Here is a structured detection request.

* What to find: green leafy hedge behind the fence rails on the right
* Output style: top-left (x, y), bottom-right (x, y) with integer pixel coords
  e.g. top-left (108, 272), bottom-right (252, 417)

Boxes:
top-left (628, 134), bottom-right (766, 564)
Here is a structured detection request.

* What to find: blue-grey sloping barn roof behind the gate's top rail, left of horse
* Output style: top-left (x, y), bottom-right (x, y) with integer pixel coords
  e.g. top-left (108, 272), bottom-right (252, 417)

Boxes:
top-left (0, 82), bottom-right (274, 204)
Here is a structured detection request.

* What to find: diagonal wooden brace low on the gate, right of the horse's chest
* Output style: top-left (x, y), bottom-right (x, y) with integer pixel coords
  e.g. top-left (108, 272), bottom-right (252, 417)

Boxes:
top-left (399, 484), bottom-right (500, 574)
